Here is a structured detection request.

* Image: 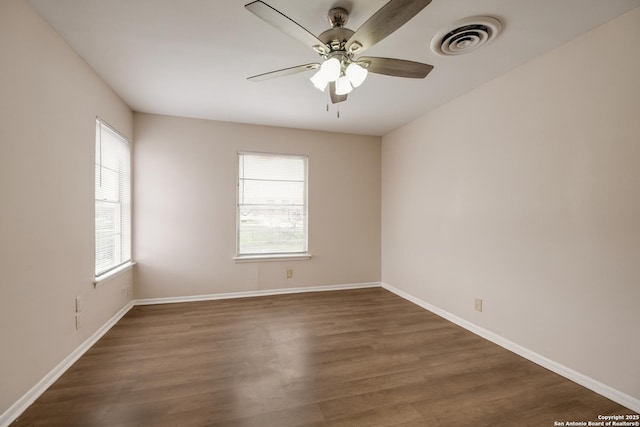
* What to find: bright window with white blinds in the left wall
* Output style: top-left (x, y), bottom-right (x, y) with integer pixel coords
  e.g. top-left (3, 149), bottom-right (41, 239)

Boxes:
top-left (95, 119), bottom-right (131, 277)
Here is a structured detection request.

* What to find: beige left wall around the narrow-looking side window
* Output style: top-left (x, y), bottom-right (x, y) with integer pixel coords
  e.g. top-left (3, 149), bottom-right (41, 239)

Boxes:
top-left (0, 0), bottom-right (132, 415)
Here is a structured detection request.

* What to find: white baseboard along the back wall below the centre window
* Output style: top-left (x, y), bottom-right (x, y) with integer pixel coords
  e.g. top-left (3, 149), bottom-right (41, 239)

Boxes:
top-left (133, 282), bottom-right (381, 305)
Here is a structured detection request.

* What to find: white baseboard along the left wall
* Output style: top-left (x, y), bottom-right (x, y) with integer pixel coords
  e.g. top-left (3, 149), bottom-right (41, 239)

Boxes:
top-left (0, 302), bottom-right (133, 427)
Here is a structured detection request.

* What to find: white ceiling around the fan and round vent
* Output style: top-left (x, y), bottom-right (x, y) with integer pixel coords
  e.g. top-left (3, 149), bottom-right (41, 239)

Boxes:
top-left (29, 0), bottom-right (640, 135)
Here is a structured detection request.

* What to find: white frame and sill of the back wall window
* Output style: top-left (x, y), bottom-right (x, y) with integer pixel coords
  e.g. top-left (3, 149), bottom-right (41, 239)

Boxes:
top-left (233, 151), bottom-right (311, 263)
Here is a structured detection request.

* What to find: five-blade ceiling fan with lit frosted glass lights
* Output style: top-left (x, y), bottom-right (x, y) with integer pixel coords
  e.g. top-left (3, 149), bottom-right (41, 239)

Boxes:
top-left (245, 0), bottom-right (433, 104)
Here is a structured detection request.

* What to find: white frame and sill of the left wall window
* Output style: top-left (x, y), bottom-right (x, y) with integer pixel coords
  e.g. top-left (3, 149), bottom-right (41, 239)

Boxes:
top-left (93, 117), bottom-right (135, 286)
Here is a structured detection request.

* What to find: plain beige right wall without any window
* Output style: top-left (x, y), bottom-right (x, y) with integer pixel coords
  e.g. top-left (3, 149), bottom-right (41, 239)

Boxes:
top-left (382, 9), bottom-right (640, 399)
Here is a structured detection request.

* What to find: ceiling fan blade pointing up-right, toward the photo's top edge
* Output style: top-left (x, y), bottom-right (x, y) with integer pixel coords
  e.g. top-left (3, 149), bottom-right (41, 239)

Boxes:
top-left (346, 0), bottom-right (431, 53)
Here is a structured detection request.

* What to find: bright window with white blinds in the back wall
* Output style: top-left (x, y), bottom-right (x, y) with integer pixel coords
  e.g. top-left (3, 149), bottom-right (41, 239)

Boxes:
top-left (237, 153), bottom-right (308, 258)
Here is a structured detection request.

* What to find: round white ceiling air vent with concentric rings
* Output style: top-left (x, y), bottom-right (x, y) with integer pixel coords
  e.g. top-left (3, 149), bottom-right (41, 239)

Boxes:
top-left (431, 16), bottom-right (502, 56)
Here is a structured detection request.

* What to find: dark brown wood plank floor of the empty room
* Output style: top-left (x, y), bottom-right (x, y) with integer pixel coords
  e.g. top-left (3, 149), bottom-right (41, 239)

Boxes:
top-left (14, 288), bottom-right (633, 427)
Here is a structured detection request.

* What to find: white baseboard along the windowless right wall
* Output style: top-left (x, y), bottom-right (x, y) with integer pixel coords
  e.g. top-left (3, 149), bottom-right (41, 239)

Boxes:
top-left (382, 283), bottom-right (640, 412)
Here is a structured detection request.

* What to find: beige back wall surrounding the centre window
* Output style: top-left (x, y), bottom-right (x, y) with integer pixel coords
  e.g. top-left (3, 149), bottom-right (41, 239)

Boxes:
top-left (134, 114), bottom-right (380, 298)
